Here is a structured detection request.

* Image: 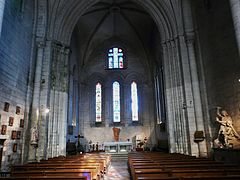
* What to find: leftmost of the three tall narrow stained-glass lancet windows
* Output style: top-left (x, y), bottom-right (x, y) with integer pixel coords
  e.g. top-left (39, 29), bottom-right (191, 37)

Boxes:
top-left (96, 83), bottom-right (102, 122)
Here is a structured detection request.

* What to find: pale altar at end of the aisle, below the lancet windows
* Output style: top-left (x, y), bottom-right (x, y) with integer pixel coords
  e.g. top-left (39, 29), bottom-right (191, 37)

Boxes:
top-left (104, 141), bottom-right (132, 153)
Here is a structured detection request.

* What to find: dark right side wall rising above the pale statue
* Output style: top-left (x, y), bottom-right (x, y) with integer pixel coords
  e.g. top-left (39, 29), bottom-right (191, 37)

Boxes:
top-left (193, 0), bottom-right (240, 139)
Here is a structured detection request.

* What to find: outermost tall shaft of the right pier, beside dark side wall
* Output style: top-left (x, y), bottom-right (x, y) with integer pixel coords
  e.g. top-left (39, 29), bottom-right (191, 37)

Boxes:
top-left (183, 0), bottom-right (207, 156)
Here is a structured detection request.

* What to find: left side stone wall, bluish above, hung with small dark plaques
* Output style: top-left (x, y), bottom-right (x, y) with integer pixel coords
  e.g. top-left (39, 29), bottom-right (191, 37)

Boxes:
top-left (0, 0), bottom-right (34, 171)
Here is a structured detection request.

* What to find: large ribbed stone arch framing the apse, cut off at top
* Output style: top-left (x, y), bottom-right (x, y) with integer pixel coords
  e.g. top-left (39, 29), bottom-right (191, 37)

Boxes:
top-left (37, 0), bottom-right (178, 44)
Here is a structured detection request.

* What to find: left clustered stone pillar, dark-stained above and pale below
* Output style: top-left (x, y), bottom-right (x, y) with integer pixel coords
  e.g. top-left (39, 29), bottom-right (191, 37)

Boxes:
top-left (46, 42), bottom-right (69, 157)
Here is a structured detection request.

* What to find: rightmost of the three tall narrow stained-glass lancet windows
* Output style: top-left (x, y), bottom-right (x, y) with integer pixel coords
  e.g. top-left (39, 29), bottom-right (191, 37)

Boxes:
top-left (131, 81), bottom-right (138, 121)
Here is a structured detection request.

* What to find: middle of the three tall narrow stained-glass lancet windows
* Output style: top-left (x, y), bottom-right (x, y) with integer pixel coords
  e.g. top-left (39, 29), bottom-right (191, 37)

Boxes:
top-left (113, 81), bottom-right (120, 122)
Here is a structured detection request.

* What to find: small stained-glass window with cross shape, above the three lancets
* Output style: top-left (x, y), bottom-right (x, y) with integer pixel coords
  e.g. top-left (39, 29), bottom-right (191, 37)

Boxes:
top-left (108, 47), bottom-right (123, 69)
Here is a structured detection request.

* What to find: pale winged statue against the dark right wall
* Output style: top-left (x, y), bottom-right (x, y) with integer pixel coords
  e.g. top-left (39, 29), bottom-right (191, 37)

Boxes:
top-left (216, 107), bottom-right (240, 147)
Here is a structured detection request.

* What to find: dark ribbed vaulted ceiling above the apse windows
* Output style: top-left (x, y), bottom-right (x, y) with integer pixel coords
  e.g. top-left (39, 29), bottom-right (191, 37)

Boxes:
top-left (72, 0), bottom-right (157, 68)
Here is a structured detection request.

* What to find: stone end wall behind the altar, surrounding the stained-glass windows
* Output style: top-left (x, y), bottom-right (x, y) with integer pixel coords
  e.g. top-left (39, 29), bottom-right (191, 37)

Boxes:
top-left (68, 35), bottom-right (156, 150)
